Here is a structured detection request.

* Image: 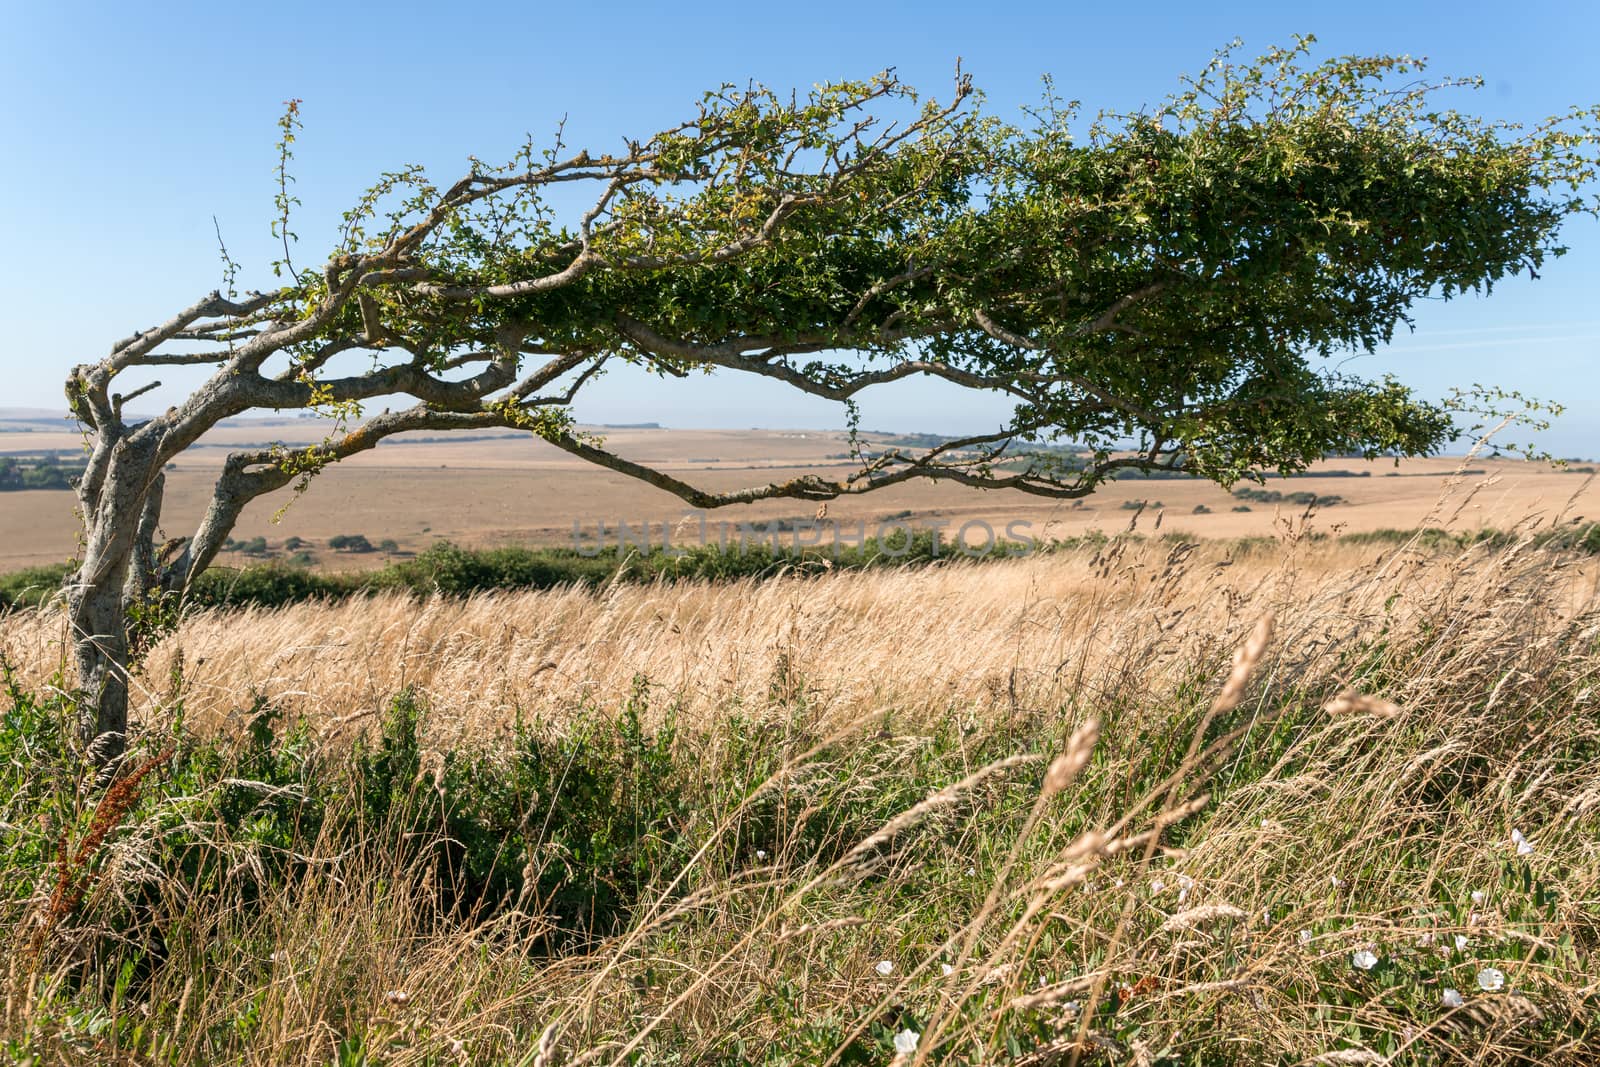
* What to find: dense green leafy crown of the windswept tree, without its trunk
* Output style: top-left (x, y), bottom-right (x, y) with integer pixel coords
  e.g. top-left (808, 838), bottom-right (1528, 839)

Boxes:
top-left (232, 37), bottom-right (1595, 508)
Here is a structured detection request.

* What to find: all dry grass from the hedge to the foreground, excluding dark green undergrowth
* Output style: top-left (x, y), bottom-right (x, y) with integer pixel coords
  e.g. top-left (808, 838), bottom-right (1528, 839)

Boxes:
top-left (0, 515), bottom-right (1600, 1067)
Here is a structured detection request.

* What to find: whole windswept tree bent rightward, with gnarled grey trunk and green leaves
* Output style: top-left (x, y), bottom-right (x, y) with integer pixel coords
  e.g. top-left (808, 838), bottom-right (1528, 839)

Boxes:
top-left (67, 42), bottom-right (1594, 760)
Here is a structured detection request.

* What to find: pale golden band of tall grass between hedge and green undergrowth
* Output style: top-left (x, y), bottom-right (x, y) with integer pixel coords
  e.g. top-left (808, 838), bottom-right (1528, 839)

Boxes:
top-left (0, 541), bottom-right (1597, 739)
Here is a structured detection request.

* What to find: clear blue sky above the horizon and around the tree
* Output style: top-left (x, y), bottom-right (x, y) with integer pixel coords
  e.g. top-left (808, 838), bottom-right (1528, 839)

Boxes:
top-left (0, 0), bottom-right (1600, 456)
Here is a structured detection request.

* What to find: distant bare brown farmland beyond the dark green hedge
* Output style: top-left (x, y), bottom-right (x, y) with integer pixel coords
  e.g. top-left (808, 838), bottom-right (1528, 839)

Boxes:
top-left (0, 416), bottom-right (1600, 571)
